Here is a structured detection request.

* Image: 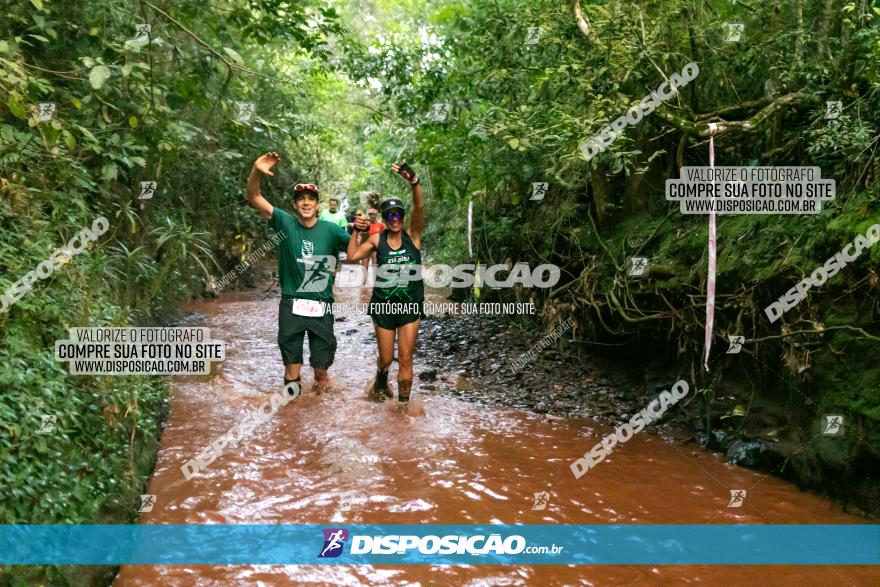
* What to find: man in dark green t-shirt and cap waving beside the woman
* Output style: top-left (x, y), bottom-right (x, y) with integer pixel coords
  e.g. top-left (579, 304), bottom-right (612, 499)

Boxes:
top-left (247, 152), bottom-right (349, 395)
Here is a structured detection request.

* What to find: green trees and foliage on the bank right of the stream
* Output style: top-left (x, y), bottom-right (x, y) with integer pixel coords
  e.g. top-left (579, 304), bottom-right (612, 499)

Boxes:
top-left (337, 0), bottom-right (880, 482)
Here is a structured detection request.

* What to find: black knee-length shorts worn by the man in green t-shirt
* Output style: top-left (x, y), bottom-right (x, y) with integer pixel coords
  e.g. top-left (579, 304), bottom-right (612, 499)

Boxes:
top-left (278, 297), bottom-right (336, 369)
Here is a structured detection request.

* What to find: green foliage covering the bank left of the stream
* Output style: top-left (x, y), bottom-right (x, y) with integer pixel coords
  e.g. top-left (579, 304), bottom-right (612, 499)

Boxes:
top-left (0, 0), bottom-right (342, 584)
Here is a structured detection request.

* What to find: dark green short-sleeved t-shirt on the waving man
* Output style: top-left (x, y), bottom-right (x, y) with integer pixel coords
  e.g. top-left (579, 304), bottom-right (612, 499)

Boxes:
top-left (269, 207), bottom-right (350, 303)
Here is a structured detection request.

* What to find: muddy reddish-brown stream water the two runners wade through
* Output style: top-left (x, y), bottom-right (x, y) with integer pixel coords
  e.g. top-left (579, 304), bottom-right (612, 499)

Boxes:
top-left (115, 282), bottom-right (880, 587)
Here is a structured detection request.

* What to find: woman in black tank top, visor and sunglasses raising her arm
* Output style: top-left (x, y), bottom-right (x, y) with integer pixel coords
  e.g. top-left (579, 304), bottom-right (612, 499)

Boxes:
top-left (346, 161), bottom-right (425, 402)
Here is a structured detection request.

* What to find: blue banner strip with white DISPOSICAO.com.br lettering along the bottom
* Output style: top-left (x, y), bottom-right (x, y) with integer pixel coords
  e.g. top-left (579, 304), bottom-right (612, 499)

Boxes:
top-left (0, 524), bottom-right (880, 565)
